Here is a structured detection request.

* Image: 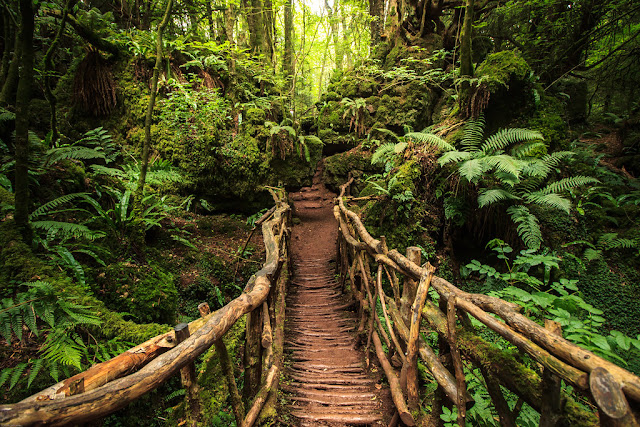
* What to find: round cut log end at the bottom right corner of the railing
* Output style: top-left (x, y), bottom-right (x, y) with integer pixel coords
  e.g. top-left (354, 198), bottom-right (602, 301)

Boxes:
top-left (589, 368), bottom-right (638, 427)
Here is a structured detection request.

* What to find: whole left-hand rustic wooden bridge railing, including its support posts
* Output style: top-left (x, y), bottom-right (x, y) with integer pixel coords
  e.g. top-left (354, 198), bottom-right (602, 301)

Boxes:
top-left (0, 189), bottom-right (290, 427)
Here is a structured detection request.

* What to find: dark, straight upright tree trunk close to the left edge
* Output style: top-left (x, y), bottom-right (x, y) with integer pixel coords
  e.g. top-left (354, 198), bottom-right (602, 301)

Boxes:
top-left (15, 0), bottom-right (35, 241)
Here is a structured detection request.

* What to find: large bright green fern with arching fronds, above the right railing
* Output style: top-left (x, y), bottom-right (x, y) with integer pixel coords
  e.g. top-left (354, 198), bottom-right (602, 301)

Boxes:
top-left (428, 116), bottom-right (599, 249)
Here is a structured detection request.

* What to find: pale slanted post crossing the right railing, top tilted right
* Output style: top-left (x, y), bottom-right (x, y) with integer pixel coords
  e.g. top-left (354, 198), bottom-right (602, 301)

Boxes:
top-left (402, 264), bottom-right (436, 411)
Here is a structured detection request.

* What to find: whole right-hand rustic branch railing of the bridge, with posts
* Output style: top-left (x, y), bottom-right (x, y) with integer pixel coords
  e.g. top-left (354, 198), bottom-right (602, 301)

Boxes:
top-left (334, 180), bottom-right (640, 426)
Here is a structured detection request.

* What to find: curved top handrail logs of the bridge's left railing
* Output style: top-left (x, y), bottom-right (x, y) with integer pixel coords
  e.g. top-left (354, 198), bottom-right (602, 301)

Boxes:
top-left (0, 196), bottom-right (290, 426)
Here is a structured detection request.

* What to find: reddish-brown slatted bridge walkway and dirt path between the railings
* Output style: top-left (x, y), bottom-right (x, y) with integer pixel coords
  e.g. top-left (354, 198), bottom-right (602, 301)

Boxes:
top-left (283, 169), bottom-right (388, 426)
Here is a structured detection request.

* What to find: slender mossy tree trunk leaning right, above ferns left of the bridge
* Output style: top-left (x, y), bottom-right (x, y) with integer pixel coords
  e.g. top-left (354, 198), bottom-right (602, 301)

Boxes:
top-left (134, 0), bottom-right (173, 207)
